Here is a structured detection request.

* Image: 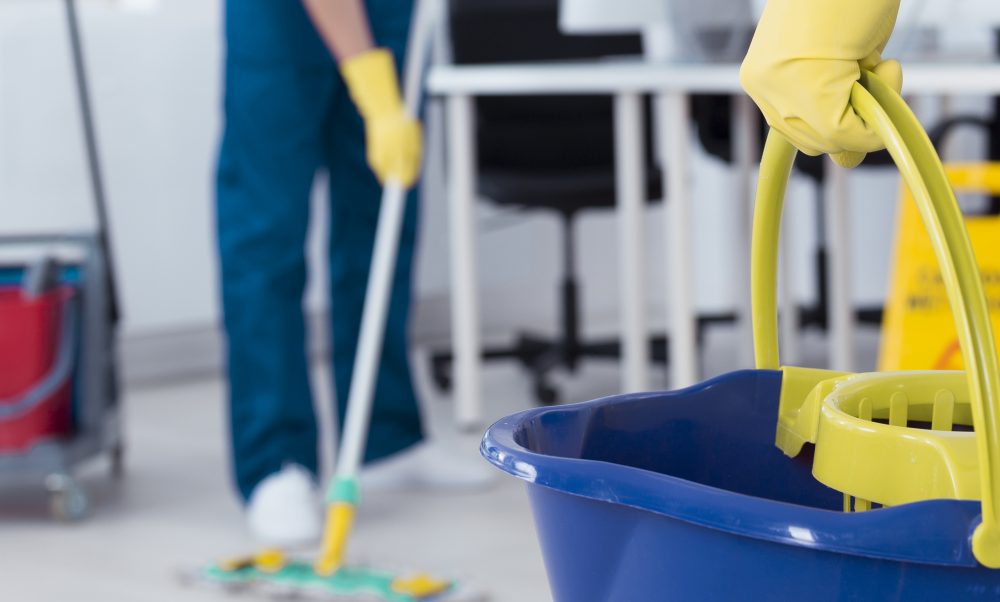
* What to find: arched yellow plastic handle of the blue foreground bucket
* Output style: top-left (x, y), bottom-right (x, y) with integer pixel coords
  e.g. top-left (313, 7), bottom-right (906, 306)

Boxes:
top-left (750, 72), bottom-right (1000, 568)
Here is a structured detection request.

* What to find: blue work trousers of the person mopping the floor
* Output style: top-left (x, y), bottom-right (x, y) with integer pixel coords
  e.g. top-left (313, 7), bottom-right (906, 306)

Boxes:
top-left (216, 0), bottom-right (423, 499)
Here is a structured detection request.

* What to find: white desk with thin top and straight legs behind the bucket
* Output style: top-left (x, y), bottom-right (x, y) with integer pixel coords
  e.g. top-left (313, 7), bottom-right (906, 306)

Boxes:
top-left (427, 60), bottom-right (1000, 425)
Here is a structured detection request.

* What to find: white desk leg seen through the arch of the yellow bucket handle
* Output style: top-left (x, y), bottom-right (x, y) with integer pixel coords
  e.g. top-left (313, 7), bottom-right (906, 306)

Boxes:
top-left (823, 159), bottom-right (854, 371)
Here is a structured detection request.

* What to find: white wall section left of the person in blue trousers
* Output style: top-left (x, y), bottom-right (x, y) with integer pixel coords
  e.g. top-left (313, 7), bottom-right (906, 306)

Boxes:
top-left (0, 0), bottom-right (225, 333)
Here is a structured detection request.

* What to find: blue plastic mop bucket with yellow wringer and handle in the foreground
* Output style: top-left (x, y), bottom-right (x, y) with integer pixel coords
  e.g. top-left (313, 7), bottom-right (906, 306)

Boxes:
top-left (482, 74), bottom-right (1000, 602)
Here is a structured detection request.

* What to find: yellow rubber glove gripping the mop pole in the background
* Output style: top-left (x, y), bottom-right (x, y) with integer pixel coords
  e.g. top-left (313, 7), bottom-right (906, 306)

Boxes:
top-left (340, 48), bottom-right (422, 188)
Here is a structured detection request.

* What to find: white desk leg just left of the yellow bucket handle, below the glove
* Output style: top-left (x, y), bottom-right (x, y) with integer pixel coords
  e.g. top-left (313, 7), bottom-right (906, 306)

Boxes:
top-left (732, 94), bottom-right (760, 367)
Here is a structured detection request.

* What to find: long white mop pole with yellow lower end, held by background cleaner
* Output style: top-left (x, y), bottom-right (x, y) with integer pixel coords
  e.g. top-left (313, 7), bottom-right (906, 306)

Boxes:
top-left (315, 0), bottom-right (439, 574)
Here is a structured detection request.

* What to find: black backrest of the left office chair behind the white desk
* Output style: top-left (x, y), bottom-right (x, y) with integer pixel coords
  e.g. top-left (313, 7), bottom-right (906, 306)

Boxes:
top-left (448, 0), bottom-right (642, 171)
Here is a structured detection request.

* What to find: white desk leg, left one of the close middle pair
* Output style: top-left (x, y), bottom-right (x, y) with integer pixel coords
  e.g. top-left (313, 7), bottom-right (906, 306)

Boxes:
top-left (614, 93), bottom-right (649, 393)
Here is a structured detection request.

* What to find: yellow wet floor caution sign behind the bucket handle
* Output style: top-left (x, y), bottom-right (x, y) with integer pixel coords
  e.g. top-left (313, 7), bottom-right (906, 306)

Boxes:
top-left (879, 163), bottom-right (1000, 370)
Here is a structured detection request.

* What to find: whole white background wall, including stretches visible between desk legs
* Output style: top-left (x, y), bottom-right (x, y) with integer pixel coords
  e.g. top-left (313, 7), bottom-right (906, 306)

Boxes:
top-left (0, 0), bottom-right (996, 376)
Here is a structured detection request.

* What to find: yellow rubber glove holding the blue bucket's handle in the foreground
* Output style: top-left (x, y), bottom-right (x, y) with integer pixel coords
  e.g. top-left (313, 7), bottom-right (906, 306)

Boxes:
top-left (740, 0), bottom-right (903, 167)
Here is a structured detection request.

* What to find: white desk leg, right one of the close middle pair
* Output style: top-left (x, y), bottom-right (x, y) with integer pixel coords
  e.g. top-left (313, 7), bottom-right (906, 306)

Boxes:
top-left (656, 92), bottom-right (698, 388)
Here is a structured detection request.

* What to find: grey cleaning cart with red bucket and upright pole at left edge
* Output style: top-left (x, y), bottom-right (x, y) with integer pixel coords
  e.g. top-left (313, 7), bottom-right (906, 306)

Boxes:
top-left (0, 0), bottom-right (124, 520)
